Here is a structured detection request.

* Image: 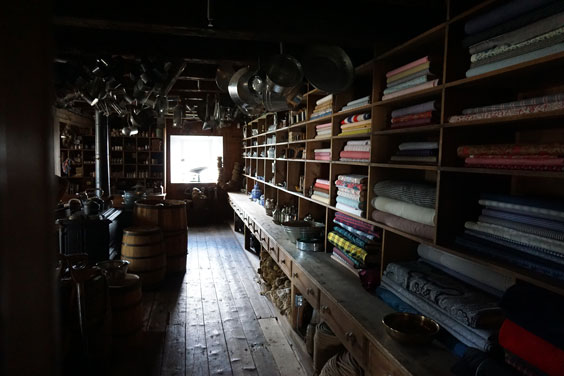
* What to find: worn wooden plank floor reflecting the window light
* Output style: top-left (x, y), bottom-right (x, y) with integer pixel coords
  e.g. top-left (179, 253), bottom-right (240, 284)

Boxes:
top-left (112, 225), bottom-right (306, 376)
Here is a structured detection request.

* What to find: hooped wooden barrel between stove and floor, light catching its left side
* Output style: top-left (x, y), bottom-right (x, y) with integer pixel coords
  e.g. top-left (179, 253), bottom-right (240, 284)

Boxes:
top-left (121, 226), bottom-right (166, 288)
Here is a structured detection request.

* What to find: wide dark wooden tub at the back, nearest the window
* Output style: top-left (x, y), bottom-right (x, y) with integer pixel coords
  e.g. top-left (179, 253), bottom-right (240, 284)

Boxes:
top-left (133, 200), bottom-right (186, 232)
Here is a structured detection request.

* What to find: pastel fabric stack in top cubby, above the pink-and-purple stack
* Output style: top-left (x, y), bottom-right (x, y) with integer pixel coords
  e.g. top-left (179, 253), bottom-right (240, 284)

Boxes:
top-left (382, 56), bottom-right (439, 100)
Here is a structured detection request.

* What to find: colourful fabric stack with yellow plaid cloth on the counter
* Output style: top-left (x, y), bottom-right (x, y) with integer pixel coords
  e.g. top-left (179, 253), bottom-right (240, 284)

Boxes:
top-left (327, 212), bottom-right (381, 275)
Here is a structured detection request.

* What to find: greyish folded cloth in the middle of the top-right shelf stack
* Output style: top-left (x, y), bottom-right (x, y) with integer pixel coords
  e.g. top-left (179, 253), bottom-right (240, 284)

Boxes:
top-left (469, 12), bottom-right (564, 54)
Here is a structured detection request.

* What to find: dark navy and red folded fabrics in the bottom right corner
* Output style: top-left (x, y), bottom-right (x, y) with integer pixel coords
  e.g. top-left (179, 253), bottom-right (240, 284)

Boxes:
top-left (499, 284), bottom-right (564, 376)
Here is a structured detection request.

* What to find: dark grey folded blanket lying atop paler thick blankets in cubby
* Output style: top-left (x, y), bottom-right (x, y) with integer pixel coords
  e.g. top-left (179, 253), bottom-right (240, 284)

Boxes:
top-left (373, 180), bottom-right (437, 209)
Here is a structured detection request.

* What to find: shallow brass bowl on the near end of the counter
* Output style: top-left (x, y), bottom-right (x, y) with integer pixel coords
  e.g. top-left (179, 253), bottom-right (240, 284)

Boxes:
top-left (382, 312), bottom-right (440, 345)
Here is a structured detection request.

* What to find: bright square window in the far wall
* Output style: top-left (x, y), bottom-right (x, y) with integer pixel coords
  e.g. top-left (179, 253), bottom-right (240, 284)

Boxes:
top-left (170, 136), bottom-right (223, 183)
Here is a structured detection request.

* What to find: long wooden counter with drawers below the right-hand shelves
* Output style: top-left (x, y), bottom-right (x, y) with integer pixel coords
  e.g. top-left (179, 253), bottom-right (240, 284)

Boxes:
top-left (229, 193), bottom-right (457, 376)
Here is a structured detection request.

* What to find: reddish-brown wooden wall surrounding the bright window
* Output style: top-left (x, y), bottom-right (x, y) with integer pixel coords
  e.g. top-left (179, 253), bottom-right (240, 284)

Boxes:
top-left (165, 119), bottom-right (243, 199)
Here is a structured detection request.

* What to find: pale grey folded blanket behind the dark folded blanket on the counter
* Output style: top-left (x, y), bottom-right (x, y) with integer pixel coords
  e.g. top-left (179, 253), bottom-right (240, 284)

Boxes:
top-left (417, 244), bottom-right (515, 296)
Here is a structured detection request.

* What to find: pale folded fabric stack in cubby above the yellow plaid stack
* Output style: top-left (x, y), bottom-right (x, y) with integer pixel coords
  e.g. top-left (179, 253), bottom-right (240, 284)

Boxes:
top-left (335, 174), bottom-right (368, 217)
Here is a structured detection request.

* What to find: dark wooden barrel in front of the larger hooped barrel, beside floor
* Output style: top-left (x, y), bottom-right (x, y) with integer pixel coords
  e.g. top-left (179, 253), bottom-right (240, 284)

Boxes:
top-left (110, 273), bottom-right (143, 337)
